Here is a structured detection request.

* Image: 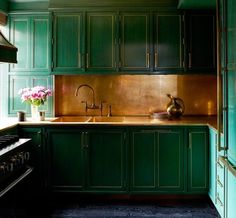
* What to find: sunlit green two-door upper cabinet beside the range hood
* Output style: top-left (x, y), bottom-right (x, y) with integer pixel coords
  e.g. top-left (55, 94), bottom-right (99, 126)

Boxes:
top-left (10, 13), bottom-right (51, 75)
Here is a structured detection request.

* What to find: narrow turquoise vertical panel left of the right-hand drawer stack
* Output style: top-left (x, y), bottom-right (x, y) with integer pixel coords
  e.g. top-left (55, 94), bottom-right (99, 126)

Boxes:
top-left (208, 128), bottom-right (217, 204)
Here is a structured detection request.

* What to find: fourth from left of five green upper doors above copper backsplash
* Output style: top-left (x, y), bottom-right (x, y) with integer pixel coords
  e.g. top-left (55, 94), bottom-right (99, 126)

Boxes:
top-left (154, 14), bottom-right (183, 70)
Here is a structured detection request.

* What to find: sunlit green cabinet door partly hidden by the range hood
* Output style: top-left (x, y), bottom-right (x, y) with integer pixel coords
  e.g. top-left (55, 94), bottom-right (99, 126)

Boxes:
top-left (10, 16), bottom-right (31, 71)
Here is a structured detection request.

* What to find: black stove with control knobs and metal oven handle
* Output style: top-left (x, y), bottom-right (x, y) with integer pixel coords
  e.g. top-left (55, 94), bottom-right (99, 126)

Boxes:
top-left (0, 135), bottom-right (33, 197)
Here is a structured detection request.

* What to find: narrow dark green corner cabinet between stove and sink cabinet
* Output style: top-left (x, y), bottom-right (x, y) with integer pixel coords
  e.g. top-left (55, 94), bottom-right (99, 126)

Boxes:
top-left (18, 126), bottom-right (46, 194)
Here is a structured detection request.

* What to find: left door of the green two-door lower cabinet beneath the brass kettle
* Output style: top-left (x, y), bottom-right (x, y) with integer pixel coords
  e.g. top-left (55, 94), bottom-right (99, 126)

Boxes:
top-left (130, 130), bottom-right (157, 191)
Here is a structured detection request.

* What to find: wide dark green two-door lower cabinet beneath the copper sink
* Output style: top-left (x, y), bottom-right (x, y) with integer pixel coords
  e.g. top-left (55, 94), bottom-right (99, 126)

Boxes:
top-left (47, 128), bottom-right (127, 192)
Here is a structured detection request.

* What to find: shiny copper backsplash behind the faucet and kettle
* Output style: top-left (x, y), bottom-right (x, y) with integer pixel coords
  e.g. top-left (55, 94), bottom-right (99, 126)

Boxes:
top-left (55, 75), bottom-right (217, 116)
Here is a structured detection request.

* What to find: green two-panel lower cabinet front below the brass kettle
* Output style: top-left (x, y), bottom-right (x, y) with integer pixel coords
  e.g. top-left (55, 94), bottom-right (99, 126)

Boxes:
top-left (130, 127), bottom-right (185, 193)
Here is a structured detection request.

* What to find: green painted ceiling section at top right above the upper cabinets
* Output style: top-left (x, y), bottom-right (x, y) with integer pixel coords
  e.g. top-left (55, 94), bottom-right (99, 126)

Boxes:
top-left (178, 0), bottom-right (216, 9)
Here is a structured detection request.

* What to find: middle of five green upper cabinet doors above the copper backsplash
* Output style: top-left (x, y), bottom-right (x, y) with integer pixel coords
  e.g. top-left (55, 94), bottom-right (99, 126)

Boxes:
top-left (120, 13), bottom-right (150, 71)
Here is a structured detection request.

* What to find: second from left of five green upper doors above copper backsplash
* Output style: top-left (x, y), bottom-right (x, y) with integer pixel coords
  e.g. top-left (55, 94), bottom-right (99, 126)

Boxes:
top-left (86, 12), bottom-right (117, 70)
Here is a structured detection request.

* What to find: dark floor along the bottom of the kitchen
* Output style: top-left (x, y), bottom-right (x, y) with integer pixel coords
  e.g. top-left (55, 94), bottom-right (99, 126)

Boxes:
top-left (0, 193), bottom-right (219, 218)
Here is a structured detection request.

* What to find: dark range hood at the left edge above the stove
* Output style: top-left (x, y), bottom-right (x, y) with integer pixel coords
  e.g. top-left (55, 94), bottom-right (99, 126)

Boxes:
top-left (0, 31), bottom-right (18, 63)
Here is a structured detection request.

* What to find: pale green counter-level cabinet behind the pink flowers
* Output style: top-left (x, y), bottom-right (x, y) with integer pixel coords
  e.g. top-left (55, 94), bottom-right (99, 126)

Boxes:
top-left (8, 75), bottom-right (53, 117)
